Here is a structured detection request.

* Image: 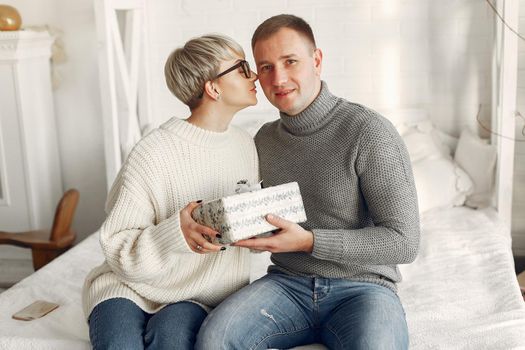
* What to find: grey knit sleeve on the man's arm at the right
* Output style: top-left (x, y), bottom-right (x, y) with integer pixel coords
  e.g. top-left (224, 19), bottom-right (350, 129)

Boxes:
top-left (312, 118), bottom-right (420, 265)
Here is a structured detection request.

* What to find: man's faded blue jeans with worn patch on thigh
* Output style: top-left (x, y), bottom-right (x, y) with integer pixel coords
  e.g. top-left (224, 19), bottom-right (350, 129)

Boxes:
top-left (196, 272), bottom-right (408, 350)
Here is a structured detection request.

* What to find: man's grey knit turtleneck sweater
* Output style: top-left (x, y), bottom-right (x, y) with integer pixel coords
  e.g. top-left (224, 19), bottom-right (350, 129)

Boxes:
top-left (255, 82), bottom-right (419, 291)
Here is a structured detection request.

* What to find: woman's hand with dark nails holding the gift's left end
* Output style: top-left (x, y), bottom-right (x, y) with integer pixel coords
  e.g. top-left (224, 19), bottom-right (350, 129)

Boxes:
top-left (180, 202), bottom-right (226, 254)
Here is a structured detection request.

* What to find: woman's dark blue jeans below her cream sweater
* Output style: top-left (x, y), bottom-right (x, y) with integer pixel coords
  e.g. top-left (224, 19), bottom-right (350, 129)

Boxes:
top-left (89, 298), bottom-right (207, 350)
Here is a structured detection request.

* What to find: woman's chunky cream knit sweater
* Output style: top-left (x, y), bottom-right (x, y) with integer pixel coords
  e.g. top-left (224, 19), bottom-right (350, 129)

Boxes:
top-left (83, 118), bottom-right (258, 317)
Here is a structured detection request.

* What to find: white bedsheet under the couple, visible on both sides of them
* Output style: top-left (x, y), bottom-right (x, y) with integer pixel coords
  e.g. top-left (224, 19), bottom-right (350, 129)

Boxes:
top-left (0, 207), bottom-right (525, 350)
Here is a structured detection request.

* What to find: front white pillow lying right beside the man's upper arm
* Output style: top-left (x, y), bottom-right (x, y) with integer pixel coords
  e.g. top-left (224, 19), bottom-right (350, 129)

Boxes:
top-left (412, 157), bottom-right (473, 213)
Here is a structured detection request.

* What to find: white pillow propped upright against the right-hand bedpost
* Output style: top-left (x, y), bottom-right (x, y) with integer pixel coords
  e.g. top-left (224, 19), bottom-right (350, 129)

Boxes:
top-left (454, 129), bottom-right (497, 208)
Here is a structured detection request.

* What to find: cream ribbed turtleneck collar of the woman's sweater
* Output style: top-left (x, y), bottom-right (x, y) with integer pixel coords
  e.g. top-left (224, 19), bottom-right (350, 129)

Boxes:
top-left (161, 117), bottom-right (232, 147)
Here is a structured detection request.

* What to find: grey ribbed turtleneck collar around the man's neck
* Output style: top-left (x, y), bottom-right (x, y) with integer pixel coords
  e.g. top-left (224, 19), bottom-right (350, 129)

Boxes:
top-left (280, 81), bottom-right (338, 135)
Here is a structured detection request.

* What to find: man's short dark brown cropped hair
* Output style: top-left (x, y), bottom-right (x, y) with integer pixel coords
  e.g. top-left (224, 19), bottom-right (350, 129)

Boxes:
top-left (252, 14), bottom-right (317, 50)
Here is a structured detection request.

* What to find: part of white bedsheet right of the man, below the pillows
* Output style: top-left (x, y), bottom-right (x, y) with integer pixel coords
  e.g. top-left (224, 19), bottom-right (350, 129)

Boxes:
top-left (399, 207), bottom-right (525, 349)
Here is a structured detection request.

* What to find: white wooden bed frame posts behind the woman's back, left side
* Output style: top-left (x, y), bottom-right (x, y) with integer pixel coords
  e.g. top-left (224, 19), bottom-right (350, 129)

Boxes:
top-left (94, 0), bottom-right (152, 191)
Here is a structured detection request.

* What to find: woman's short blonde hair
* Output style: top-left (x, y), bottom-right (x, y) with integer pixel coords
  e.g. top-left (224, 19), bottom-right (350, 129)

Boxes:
top-left (164, 34), bottom-right (244, 109)
